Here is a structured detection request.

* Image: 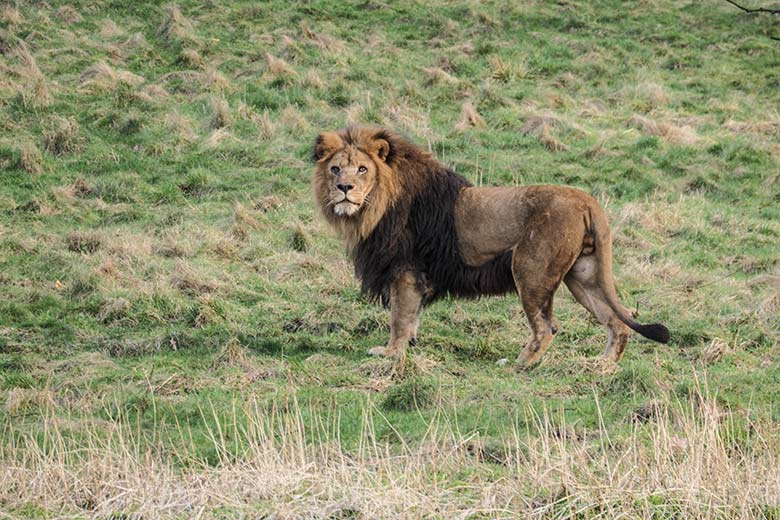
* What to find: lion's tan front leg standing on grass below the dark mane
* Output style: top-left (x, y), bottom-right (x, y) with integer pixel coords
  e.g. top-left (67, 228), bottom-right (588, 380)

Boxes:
top-left (368, 271), bottom-right (423, 357)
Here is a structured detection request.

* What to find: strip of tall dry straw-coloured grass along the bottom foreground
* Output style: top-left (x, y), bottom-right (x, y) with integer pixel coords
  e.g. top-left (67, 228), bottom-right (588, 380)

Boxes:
top-left (0, 382), bottom-right (780, 519)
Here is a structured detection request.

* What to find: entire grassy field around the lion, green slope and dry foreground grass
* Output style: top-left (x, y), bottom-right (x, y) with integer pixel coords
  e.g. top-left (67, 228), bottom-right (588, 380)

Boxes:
top-left (0, 0), bottom-right (780, 519)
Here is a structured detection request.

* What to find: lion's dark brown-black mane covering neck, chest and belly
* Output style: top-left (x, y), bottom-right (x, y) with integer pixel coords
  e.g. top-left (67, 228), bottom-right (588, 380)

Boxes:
top-left (346, 129), bottom-right (515, 304)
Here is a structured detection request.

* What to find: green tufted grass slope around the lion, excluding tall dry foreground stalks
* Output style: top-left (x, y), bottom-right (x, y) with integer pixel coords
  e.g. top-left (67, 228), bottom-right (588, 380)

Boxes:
top-left (0, 0), bottom-right (780, 516)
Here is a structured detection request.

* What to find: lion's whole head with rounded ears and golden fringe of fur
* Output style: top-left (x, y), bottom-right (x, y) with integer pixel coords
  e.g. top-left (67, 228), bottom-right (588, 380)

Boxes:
top-left (313, 128), bottom-right (399, 245)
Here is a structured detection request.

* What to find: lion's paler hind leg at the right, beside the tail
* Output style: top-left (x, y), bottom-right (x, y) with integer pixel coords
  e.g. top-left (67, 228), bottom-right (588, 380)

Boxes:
top-left (564, 255), bottom-right (631, 361)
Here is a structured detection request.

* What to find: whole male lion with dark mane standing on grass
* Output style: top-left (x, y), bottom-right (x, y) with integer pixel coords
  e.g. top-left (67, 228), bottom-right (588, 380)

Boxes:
top-left (313, 128), bottom-right (669, 365)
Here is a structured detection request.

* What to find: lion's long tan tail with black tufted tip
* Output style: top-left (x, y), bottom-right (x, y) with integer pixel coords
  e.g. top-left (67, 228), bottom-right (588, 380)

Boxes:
top-left (590, 206), bottom-right (669, 343)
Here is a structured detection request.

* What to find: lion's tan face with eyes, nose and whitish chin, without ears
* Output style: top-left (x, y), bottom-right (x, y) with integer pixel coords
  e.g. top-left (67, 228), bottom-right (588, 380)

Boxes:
top-left (320, 146), bottom-right (377, 217)
